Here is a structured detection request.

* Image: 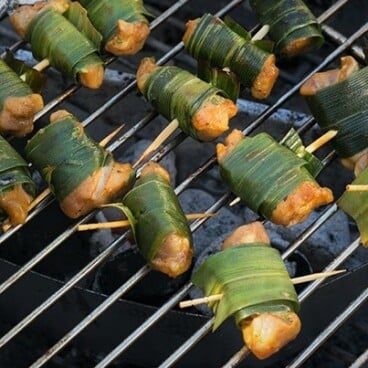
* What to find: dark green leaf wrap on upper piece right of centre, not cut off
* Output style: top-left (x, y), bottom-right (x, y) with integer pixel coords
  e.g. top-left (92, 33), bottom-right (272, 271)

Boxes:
top-left (184, 14), bottom-right (270, 87)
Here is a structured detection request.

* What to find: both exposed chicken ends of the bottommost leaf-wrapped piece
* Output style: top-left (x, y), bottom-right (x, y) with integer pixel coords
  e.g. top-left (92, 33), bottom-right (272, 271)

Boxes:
top-left (222, 222), bottom-right (301, 359)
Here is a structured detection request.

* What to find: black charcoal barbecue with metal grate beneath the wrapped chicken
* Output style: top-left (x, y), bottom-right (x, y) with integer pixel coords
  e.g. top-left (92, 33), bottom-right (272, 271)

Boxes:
top-left (0, 0), bottom-right (368, 367)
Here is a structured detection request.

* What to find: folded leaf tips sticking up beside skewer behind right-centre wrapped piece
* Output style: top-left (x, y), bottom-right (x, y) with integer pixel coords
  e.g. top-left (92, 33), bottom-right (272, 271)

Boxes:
top-left (280, 128), bottom-right (323, 178)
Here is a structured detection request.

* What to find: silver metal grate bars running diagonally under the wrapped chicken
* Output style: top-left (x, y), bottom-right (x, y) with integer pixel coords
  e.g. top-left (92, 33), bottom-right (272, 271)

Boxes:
top-left (0, 0), bottom-right (368, 368)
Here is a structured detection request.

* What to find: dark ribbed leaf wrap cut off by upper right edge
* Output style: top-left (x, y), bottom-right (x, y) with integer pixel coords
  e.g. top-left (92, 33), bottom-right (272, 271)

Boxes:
top-left (306, 67), bottom-right (368, 158)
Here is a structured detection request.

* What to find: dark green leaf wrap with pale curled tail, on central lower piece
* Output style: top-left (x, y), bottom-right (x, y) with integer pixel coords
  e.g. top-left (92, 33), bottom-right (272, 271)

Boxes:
top-left (114, 174), bottom-right (192, 262)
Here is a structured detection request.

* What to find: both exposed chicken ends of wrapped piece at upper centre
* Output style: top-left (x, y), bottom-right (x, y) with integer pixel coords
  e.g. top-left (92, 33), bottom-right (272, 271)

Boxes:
top-left (136, 58), bottom-right (238, 142)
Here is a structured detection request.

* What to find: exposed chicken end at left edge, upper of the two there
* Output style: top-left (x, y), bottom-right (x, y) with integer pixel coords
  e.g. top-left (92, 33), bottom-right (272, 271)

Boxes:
top-left (0, 93), bottom-right (43, 137)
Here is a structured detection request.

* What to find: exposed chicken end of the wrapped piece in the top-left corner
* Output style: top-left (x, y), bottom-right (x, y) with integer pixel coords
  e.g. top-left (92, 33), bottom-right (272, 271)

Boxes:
top-left (9, 0), bottom-right (70, 38)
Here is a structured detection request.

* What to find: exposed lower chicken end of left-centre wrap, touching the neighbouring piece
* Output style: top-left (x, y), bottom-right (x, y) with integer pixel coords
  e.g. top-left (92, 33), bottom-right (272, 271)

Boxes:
top-left (60, 162), bottom-right (133, 218)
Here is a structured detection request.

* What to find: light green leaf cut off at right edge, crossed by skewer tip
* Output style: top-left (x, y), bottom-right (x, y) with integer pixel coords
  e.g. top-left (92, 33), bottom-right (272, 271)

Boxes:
top-left (337, 168), bottom-right (368, 246)
